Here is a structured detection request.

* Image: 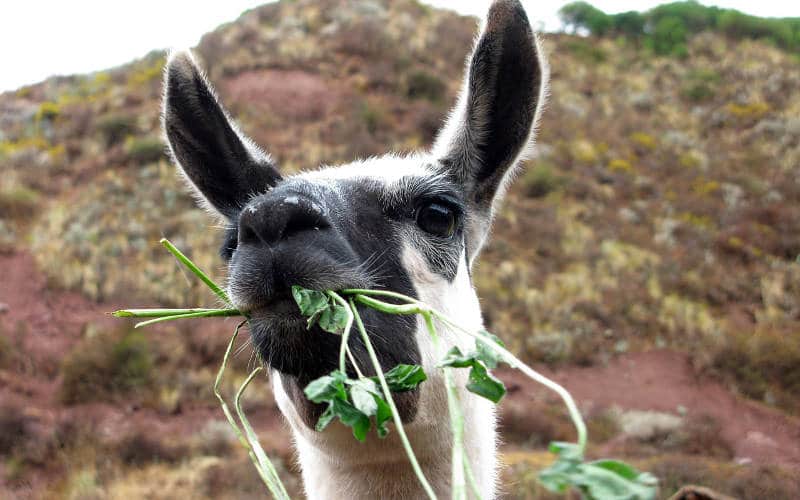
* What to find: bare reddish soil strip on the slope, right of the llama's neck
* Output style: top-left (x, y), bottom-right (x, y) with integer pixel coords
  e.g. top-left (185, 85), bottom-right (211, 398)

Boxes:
top-left (499, 350), bottom-right (800, 468)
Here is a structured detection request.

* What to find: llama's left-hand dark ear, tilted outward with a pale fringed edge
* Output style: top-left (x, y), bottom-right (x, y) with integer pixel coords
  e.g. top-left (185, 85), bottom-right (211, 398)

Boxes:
top-left (162, 51), bottom-right (281, 219)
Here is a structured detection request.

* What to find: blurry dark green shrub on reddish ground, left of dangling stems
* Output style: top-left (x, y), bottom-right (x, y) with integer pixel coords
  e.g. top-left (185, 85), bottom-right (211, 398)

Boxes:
top-left (59, 328), bottom-right (153, 404)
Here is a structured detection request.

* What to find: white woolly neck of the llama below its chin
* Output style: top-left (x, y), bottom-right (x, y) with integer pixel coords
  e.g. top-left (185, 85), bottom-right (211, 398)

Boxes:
top-left (282, 370), bottom-right (496, 499)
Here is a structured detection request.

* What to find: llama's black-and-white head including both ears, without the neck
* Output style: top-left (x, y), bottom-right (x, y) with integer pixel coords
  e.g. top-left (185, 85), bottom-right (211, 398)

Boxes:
top-left (163, 0), bottom-right (546, 426)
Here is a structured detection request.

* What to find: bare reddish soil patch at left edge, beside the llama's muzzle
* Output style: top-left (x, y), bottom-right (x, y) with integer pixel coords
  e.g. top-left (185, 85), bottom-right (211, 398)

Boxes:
top-left (0, 253), bottom-right (289, 453)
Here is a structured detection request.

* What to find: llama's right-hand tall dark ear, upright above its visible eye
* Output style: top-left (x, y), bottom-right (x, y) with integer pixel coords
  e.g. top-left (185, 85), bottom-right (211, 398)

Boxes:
top-left (433, 0), bottom-right (547, 258)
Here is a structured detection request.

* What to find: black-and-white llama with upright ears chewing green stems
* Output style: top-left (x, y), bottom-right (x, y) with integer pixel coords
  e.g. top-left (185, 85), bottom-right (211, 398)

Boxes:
top-left (163, 0), bottom-right (547, 499)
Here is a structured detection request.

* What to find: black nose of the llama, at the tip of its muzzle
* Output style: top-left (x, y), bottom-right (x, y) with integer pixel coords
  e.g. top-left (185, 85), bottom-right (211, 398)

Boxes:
top-left (239, 194), bottom-right (330, 245)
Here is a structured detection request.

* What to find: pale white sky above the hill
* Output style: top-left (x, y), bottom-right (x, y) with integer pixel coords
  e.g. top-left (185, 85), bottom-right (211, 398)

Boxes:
top-left (0, 0), bottom-right (800, 92)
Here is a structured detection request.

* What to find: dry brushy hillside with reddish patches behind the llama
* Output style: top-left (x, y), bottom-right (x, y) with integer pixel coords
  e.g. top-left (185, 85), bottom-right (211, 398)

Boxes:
top-left (0, 0), bottom-right (800, 498)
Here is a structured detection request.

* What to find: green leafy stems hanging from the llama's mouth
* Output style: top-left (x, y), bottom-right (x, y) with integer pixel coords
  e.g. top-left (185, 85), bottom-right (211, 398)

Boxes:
top-left (113, 239), bottom-right (658, 500)
